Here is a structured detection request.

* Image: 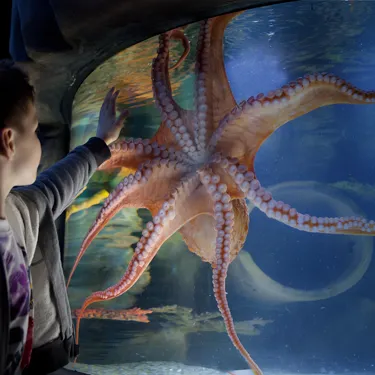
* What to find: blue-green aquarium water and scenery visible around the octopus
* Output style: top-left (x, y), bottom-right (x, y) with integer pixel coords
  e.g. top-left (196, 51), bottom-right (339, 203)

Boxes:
top-left (64, 0), bottom-right (375, 375)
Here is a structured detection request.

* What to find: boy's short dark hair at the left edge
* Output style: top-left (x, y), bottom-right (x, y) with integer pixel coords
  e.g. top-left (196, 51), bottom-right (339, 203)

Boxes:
top-left (0, 60), bottom-right (35, 129)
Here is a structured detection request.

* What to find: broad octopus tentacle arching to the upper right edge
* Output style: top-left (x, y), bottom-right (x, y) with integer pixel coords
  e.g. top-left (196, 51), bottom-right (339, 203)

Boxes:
top-left (213, 73), bottom-right (375, 169)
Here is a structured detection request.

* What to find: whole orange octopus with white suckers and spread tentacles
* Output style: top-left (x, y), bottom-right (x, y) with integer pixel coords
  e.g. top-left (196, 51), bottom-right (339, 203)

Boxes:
top-left (68, 12), bottom-right (375, 375)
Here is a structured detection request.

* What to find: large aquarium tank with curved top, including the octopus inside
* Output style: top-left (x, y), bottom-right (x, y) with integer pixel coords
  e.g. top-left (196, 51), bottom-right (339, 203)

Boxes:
top-left (64, 0), bottom-right (375, 375)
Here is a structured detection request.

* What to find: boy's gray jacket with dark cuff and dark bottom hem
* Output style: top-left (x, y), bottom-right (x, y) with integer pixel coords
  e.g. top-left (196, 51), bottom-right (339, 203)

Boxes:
top-left (6, 138), bottom-right (111, 374)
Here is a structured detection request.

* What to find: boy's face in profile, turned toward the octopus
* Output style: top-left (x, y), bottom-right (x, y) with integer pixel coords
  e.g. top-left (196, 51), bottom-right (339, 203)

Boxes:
top-left (11, 101), bottom-right (42, 186)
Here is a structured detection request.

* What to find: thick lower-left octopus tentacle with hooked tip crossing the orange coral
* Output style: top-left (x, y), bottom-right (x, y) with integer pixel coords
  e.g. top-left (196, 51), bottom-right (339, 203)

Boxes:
top-left (76, 175), bottom-right (213, 344)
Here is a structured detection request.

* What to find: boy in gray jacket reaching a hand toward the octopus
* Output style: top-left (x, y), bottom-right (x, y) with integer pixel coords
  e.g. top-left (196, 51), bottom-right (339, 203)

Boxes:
top-left (0, 61), bottom-right (127, 375)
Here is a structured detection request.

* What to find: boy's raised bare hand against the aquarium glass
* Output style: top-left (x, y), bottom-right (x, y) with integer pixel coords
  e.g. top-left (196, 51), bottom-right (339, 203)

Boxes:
top-left (96, 87), bottom-right (128, 145)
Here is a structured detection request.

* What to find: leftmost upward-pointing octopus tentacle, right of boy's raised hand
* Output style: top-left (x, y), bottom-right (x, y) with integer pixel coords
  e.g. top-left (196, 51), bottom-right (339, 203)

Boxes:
top-left (151, 32), bottom-right (196, 156)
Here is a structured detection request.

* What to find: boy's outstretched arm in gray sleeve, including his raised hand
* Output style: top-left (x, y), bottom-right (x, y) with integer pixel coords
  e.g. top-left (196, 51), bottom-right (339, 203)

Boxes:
top-left (15, 88), bottom-right (127, 219)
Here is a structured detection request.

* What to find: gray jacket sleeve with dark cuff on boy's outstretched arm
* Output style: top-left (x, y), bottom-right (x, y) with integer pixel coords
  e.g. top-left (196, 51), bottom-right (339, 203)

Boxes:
top-left (15, 137), bottom-right (111, 219)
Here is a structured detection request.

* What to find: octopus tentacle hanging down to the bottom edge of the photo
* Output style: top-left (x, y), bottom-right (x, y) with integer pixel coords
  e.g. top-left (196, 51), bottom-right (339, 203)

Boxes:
top-left (200, 171), bottom-right (262, 375)
